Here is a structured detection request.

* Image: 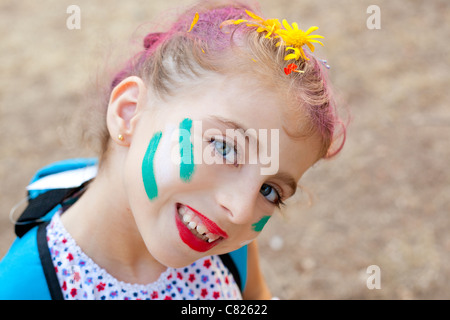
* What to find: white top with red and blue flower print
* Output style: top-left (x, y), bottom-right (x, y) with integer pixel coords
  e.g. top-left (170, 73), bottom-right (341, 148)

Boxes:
top-left (47, 213), bottom-right (242, 300)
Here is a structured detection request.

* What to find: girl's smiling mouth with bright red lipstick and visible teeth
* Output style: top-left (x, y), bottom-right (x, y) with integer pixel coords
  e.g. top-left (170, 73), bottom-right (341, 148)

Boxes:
top-left (176, 203), bottom-right (228, 252)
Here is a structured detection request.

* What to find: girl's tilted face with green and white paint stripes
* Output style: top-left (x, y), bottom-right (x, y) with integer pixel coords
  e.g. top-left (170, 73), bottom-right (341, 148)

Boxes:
top-left (124, 77), bottom-right (319, 267)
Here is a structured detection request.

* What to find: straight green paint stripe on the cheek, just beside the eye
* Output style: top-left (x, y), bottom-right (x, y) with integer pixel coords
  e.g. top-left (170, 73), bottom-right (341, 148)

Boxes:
top-left (179, 118), bottom-right (195, 182)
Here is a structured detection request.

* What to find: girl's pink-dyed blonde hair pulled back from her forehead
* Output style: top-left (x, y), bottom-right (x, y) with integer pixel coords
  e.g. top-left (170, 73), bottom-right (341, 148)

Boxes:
top-left (103, 1), bottom-right (346, 159)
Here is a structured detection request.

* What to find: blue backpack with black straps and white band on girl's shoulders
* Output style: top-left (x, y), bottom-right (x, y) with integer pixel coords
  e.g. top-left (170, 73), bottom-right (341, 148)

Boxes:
top-left (0, 158), bottom-right (247, 300)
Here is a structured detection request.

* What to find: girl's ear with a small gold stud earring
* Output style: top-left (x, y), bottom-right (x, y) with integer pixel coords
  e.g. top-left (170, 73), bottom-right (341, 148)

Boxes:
top-left (106, 76), bottom-right (147, 146)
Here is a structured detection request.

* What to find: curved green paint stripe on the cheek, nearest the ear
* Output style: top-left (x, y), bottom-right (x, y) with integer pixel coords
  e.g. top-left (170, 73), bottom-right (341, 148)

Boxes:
top-left (142, 131), bottom-right (162, 200)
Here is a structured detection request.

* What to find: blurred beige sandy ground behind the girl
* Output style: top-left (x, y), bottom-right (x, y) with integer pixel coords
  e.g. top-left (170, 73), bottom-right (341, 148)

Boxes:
top-left (0, 0), bottom-right (450, 299)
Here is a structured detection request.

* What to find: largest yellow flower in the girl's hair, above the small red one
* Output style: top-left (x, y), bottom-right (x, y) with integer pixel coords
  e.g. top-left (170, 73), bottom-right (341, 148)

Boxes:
top-left (276, 20), bottom-right (323, 60)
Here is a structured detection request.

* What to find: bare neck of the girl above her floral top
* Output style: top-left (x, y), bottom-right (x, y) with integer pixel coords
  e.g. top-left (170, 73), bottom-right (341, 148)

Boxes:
top-left (61, 159), bottom-right (167, 284)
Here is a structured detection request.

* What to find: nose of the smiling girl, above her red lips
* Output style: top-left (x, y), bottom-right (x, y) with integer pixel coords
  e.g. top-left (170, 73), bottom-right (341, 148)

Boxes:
top-left (216, 172), bottom-right (261, 224)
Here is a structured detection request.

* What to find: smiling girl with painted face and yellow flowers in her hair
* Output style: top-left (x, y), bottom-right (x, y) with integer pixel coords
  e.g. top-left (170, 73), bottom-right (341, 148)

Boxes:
top-left (0, 2), bottom-right (343, 299)
